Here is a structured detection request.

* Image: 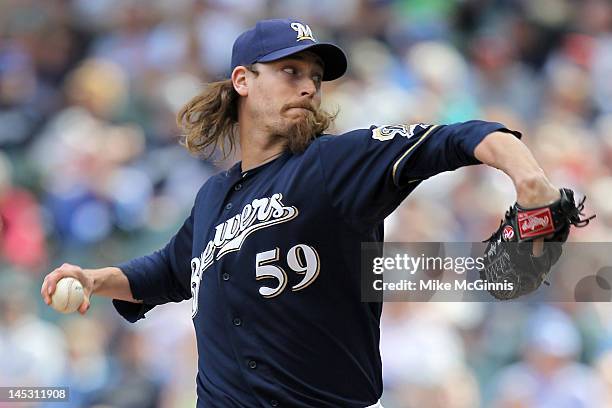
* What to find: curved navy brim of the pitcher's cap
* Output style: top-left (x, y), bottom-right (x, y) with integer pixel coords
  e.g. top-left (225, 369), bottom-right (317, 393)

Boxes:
top-left (257, 43), bottom-right (347, 81)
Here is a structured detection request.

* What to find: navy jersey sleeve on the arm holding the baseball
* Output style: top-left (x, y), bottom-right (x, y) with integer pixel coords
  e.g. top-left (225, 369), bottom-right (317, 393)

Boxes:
top-left (113, 210), bottom-right (193, 323)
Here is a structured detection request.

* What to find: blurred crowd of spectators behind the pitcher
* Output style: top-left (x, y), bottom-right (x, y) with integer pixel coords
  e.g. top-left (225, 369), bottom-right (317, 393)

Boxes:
top-left (0, 0), bottom-right (612, 408)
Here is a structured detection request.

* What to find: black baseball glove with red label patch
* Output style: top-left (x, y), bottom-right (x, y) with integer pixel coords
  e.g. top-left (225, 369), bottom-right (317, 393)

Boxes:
top-left (480, 188), bottom-right (595, 300)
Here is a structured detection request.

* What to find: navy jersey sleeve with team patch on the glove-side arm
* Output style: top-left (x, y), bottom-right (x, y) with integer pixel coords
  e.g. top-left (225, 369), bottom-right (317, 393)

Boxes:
top-left (319, 120), bottom-right (521, 231)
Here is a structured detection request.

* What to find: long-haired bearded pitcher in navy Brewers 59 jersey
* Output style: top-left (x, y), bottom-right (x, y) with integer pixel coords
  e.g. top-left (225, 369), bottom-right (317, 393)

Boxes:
top-left (41, 19), bottom-right (596, 408)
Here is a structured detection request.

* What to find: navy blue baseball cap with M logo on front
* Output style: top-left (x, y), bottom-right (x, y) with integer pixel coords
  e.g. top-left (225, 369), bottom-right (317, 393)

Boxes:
top-left (231, 19), bottom-right (347, 81)
